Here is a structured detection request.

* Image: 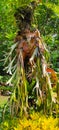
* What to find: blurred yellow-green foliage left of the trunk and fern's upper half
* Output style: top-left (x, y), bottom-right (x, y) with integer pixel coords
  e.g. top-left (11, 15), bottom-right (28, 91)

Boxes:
top-left (0, 0), bottom-right (16, 74)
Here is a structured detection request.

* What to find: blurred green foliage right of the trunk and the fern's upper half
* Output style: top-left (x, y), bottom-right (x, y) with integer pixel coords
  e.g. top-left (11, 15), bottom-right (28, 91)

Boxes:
top-left (34, 3), bottom-right (59, 72)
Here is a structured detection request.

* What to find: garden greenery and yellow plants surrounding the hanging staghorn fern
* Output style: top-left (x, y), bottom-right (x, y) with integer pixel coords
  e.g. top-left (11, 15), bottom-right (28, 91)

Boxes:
top-left (0, 0), bottom-right (59, 130)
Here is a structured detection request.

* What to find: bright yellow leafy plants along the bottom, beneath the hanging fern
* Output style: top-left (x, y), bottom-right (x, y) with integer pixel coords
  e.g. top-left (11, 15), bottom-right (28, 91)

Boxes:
top-left (4, 112), bottom-right (59, 130)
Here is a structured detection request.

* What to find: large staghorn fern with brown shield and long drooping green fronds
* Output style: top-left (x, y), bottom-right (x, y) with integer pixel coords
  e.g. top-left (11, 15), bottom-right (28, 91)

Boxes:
top-left (5, 0), bottom-right (55, 116)
